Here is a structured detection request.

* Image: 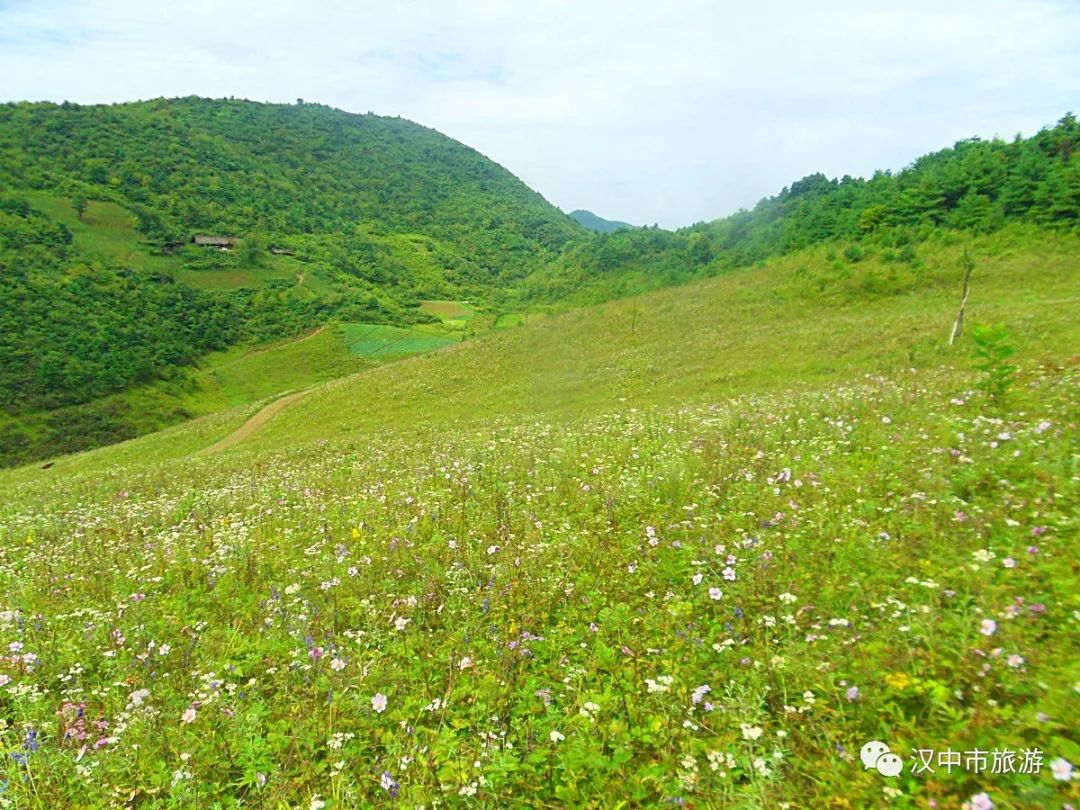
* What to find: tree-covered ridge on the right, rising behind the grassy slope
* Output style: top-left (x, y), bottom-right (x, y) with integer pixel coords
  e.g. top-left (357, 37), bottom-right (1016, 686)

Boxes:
top-left (525, 114), bottom-right (1080, 305)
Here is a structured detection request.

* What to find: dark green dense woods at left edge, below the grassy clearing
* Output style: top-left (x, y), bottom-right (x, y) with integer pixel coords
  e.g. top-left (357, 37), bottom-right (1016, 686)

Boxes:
top-left (0, 199), bottom-right (232, 414)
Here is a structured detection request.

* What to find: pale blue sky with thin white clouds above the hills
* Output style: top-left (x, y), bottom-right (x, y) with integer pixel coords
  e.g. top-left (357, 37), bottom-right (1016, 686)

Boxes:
top-left (0, 0), bottom-right (1080, 228)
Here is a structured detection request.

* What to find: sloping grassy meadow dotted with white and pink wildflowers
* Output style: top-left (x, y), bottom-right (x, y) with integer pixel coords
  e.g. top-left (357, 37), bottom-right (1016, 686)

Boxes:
top-left (0, 227), bottom-right (1080, 809)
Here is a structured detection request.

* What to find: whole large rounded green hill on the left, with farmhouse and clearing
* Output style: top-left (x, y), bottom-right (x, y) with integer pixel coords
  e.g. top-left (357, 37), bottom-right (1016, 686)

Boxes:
top-left (0, 98), bottom-right (581, 463)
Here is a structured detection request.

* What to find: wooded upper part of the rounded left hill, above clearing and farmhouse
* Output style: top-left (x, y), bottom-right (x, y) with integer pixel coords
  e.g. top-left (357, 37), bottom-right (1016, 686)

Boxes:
top-left (0, 98), bottom-right (575, 264)
